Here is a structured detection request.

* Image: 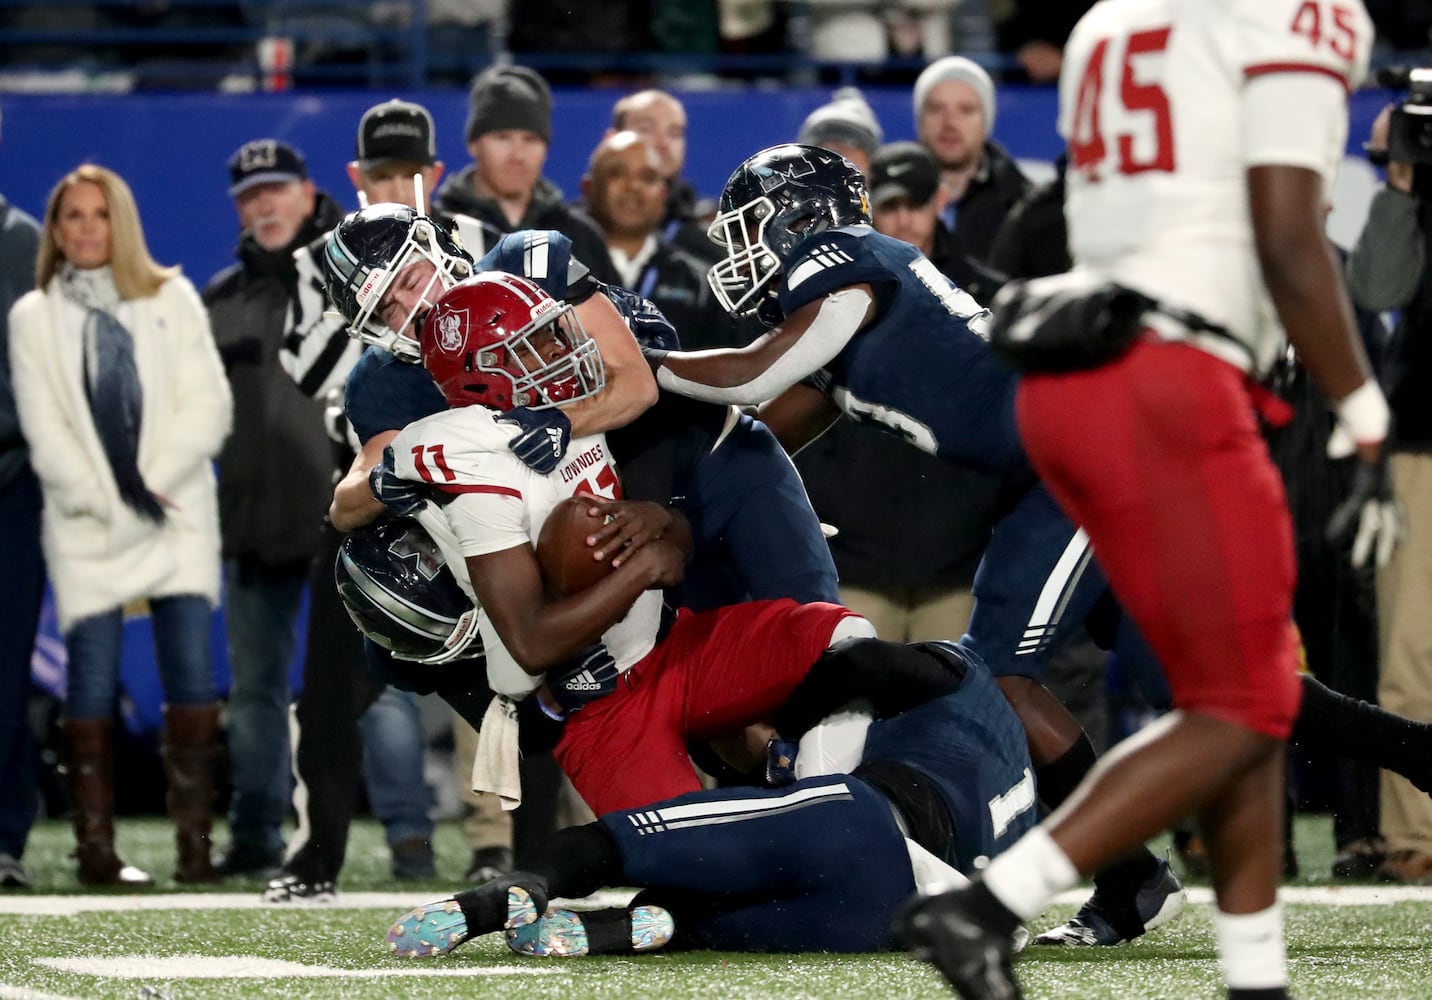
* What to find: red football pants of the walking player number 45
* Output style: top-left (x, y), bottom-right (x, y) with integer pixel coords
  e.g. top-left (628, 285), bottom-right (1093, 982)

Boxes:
top-left (1017, 337), bottom-right (1300, 738)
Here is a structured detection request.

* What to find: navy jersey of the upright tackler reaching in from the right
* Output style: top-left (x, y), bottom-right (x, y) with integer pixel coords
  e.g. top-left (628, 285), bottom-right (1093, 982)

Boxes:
top-left (778, 226), bottom-right (1027, 476)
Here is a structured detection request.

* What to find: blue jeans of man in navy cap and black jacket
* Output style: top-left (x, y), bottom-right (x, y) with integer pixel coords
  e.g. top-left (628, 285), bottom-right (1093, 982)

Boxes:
top-left (223, 560), bottom-right (306, 855)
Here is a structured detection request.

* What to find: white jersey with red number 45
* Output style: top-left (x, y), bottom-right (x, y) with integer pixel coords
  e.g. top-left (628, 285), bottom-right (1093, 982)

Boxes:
top-left (1060, 0), bottom-right (1372, 371)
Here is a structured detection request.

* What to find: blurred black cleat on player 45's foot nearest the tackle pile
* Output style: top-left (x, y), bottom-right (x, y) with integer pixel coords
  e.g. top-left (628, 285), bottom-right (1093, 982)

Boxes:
top-left (895, 890), bottom-right (1024, 1000)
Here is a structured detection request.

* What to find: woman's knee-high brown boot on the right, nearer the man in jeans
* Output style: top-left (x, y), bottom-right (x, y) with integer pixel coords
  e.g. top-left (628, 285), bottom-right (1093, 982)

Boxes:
top-left (159, 703), bottom-right (219, 883)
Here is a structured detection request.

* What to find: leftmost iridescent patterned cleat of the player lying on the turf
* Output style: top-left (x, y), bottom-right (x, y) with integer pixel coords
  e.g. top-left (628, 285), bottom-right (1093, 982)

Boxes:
top-left (388, 872), bottom-right (547, 958)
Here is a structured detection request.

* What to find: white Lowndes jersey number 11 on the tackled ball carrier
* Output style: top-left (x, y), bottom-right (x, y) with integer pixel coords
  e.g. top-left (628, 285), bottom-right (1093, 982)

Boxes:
top-left (392, 407), bottom-right (662, 698)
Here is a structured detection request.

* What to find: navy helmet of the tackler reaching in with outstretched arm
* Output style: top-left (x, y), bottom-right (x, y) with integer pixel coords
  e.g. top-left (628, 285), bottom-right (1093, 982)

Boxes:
top-left (706, 143), bottom-right (871, 327)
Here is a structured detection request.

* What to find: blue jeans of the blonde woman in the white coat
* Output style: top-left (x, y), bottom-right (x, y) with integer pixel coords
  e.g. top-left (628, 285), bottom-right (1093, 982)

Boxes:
top-left (64, 595), bottom-right (215, 719)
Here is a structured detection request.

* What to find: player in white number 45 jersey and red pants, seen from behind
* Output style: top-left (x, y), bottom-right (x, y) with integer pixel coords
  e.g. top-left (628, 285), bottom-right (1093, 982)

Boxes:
top-left (902, 0), bottom-right (1388, 1000)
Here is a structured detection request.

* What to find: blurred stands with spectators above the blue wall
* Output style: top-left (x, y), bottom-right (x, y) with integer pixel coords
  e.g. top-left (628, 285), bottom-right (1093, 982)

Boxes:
top-left (0, 0), bottom-right (1432, 92)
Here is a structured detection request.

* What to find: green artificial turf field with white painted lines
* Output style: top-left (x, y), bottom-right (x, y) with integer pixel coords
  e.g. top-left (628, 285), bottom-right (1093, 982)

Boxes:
top-left (0, 817), bottom-right (1432, 1000)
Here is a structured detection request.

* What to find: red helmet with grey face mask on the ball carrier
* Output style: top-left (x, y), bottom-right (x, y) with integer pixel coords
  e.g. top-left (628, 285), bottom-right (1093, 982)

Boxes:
top-left (421, 271), bottom-right (606, 413)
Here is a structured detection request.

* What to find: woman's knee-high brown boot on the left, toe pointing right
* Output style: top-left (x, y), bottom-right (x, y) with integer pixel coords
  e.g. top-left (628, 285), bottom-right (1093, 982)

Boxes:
top-left (64, 719), bottom-right (155, 885)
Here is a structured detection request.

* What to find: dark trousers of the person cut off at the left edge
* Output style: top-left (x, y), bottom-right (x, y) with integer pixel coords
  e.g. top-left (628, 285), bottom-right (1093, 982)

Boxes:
top-left (0, 466), bottom-right (44, 860)
